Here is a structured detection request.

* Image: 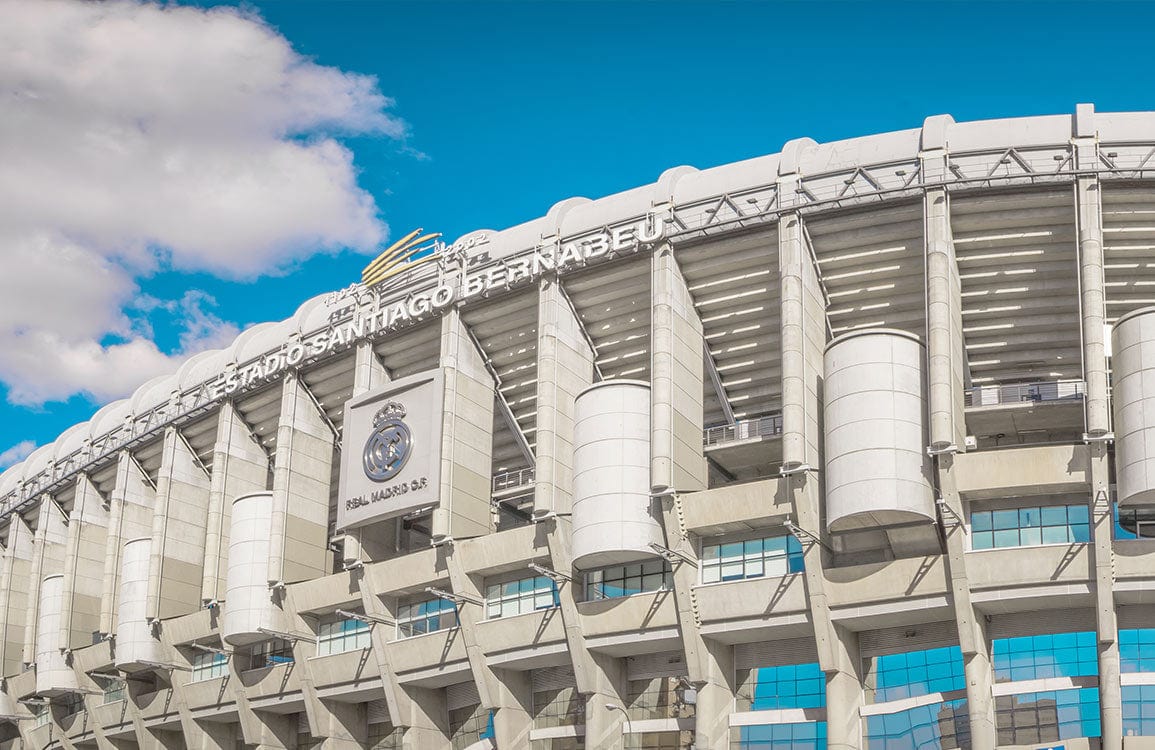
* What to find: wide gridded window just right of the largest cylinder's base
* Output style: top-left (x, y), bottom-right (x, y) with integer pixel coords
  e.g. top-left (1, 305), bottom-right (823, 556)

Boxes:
top-left (970, 505), bottom-right (1090, 549)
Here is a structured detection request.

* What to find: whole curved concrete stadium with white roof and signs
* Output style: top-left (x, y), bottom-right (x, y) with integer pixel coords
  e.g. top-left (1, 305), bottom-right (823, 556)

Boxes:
top-left (0, 104), bottom-right (1155, 750)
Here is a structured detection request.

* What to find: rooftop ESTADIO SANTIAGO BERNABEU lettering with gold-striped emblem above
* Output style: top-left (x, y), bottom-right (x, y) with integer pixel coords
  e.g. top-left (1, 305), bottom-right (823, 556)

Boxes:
top-left (211, 214), bottom-right (669, 399)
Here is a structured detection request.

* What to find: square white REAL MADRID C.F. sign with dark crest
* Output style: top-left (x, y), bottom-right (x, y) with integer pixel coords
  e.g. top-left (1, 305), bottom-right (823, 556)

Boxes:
top-left (337, 370), bottom-right (445, 529)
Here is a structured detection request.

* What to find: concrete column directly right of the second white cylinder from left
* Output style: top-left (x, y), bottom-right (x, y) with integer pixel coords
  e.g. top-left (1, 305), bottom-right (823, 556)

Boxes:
top-left (146, 426), bottom-right (209, 619)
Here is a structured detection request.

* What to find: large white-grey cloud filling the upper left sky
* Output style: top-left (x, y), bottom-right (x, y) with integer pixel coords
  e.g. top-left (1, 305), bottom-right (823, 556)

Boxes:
top-left (0, 0), bottom-right (404, 403)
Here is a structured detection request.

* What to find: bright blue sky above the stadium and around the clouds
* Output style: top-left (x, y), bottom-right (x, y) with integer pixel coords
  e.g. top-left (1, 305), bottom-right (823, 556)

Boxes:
top-left (0, 0), bottom-right (1155, 468)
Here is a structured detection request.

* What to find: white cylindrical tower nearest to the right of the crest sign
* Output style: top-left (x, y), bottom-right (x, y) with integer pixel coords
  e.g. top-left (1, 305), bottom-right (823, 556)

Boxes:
top-left (573, 380), bottom-right (664, 569)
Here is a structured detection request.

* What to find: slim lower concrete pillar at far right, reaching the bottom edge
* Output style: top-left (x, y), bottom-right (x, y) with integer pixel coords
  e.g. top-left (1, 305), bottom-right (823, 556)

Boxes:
top-left (1088, 440), bottom-right (1123, 750)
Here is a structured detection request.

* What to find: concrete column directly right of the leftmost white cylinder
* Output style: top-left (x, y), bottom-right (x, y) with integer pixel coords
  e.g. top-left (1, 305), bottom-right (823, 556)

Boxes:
top-left (60, 473), bottom-right (109, 648)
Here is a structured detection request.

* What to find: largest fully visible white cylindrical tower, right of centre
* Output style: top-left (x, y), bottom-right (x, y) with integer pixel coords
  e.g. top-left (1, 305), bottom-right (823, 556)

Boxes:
top-left (824, 328), bottom-right (934, 530)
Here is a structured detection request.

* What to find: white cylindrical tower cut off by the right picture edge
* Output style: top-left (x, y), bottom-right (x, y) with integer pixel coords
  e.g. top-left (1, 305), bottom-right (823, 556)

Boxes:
top-left (1111, 307), bottom-right (1155, 505)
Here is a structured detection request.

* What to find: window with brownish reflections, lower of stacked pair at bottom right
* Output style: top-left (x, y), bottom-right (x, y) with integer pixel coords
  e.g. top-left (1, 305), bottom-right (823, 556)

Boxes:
top-left (994, 688), bottom-right (1102, 747)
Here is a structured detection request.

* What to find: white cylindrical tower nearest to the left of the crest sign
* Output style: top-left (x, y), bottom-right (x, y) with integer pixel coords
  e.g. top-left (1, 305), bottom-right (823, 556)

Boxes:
top-left (221, 492), bottom-right (284, 646)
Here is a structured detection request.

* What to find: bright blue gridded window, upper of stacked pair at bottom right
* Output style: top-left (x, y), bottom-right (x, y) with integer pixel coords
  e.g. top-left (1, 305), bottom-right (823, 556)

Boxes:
top-left (991, 631), bottom-right (1098, 682)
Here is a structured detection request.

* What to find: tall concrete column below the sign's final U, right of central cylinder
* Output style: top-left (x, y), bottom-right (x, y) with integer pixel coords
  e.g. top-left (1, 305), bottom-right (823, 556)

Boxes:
top-left (650, 245), bottom-right (707, 492)
